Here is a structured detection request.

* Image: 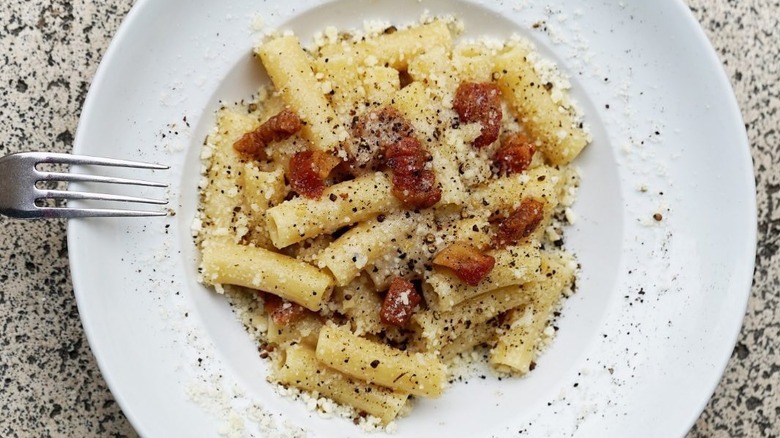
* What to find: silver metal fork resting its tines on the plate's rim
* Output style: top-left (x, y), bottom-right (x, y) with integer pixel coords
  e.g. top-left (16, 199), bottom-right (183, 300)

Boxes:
top-left (0, 152), bottom-right (168, 219)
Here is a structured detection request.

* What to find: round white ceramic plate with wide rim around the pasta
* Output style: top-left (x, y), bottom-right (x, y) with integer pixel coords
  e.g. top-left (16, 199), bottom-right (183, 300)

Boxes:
top-left (68, 0), bottom-right (756, 437)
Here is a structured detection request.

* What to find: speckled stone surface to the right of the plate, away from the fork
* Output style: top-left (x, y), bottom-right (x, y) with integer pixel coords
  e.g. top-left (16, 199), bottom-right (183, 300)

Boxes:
top-left (688, 0), bottom-right (780, 437)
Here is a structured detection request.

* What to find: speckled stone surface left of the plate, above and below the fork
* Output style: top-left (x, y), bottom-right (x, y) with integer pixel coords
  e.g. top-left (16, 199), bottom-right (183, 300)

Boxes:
top-left (0, 0), bottom-right (134, 437)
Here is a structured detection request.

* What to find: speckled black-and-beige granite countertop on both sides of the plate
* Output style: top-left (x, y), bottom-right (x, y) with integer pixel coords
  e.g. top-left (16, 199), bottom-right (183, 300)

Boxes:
top-left (0, 0), bottom-right (780, 437)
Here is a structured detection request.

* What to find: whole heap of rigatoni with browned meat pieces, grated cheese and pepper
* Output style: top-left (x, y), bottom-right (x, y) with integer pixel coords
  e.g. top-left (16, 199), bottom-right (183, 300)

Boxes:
top-left (194, 19), bottom-right (589, 424)
